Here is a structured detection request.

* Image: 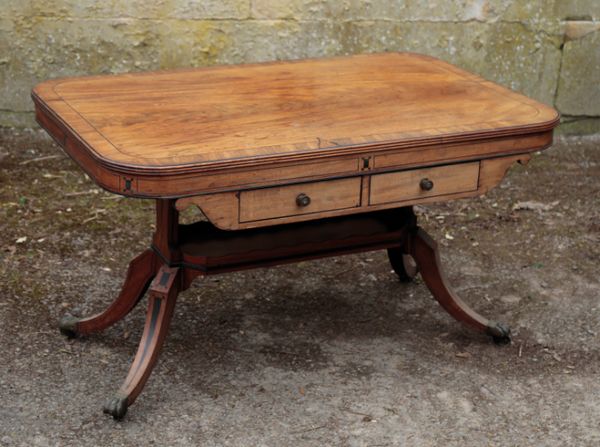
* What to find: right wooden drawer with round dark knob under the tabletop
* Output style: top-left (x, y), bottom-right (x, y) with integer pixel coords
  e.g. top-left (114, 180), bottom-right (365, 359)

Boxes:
top-left (369, 162), bottom-right (479, 205)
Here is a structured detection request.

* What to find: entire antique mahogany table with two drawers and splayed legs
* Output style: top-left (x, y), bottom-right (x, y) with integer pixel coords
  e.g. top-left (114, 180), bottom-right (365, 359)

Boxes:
top-left (32, 53), bottom-right (559, 419)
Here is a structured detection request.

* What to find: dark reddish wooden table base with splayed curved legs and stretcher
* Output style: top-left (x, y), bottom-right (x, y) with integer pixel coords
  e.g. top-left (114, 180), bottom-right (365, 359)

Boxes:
top-left (60, 199), bottom-right (510, 419)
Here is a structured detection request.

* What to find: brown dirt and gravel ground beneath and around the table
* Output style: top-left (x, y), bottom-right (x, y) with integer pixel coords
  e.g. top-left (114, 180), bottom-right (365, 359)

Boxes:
top-left (0, 130), bottom-right (600, 447)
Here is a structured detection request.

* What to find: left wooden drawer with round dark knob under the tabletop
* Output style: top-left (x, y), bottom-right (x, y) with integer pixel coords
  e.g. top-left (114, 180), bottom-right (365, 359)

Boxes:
top-left (240, 177), bottom-right (361, 222)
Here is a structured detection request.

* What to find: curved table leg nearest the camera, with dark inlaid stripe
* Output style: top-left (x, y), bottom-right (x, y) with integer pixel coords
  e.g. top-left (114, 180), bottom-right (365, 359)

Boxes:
top-left (104, 266), bottom-right (181, 420)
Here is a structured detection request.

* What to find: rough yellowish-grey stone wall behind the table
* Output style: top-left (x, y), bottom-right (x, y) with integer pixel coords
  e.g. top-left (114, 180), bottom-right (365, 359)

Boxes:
top-left (0, 0), bottom-right (600, 133)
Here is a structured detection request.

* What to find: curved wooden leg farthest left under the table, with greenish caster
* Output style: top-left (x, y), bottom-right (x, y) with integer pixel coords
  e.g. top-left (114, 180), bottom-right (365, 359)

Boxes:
top-left (59, 250), bottom-right (158, 337)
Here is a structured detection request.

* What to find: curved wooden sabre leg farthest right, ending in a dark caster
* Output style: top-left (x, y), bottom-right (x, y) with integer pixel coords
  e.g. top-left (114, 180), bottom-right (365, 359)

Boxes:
top-left (407, 228), bottom-right (510, 344)
